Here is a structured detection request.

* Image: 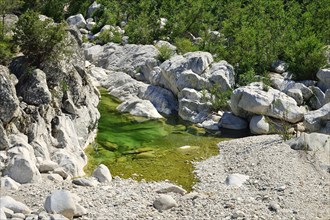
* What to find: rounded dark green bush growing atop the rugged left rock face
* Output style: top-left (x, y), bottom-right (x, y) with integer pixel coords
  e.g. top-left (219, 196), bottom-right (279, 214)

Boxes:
top-left (14, 10), bottom-right (66, 66)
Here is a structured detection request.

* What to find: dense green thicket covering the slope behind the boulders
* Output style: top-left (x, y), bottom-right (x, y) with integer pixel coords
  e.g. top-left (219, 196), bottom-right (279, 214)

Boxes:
top-left (0, 0), bottom-right (330, 81)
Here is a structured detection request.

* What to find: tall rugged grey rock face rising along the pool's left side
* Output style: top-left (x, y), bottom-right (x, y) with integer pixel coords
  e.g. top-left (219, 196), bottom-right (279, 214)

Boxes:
top-left (0, 29), bottom-right (100, 183)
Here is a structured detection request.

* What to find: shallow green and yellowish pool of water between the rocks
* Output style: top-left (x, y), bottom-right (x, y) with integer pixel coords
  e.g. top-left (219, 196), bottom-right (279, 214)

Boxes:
top-left (85, 89), bottom-right (229, 191)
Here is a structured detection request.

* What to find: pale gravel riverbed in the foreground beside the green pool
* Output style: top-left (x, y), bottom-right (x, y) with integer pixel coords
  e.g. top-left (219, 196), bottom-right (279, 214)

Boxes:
top-left (1, 135), bottom-right (330, 220)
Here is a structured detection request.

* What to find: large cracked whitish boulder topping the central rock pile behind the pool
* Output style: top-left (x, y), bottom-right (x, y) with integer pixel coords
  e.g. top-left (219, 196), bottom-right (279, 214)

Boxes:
top-left (158, 52), bottom-right (234, 95)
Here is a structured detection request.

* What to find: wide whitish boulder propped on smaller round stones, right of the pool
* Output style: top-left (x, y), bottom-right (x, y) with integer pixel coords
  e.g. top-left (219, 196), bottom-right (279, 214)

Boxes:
top-left (230, 83), bottom-right (305, 123)
